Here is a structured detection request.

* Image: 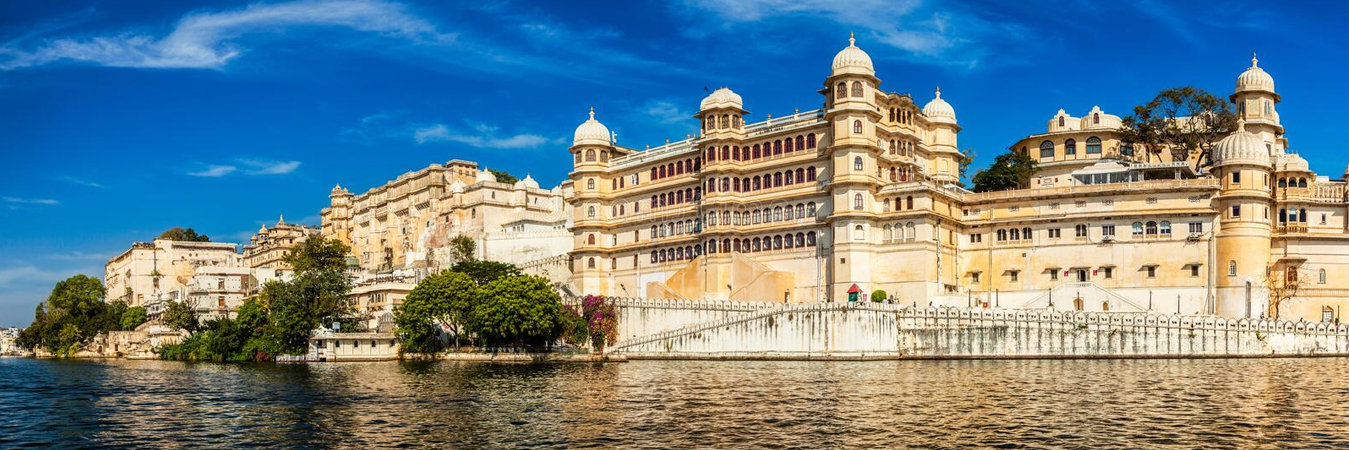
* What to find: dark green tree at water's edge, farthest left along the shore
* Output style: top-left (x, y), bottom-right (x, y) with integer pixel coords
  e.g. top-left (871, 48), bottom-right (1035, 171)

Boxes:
top-left (16, 275), bottom-right (109, 356)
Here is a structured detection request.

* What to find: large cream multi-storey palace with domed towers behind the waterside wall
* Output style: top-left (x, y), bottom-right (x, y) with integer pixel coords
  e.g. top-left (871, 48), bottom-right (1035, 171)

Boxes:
top-left (563, 39), bottom-right (1349, 321)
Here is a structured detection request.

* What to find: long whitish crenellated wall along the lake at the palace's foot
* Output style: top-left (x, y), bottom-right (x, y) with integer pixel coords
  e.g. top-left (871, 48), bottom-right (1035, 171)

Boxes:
top-left (612, 302), bottom-right (1349, 360)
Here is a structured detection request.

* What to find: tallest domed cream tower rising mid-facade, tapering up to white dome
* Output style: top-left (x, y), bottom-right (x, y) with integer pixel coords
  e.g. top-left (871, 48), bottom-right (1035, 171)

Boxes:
top-left (823, 35), bottom-right (882, 300)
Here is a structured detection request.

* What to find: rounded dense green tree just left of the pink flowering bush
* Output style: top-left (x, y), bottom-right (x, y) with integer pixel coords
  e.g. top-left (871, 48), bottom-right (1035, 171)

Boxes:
top-left (471, 276), bottom-right (565, 348)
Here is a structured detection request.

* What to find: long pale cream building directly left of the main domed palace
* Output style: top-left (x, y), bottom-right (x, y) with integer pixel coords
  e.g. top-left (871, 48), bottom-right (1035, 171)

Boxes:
top-left (321, 159), bottom-right (573, 277)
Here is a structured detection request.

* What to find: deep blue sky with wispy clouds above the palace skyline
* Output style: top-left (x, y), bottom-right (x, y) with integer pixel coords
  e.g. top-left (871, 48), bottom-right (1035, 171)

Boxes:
top-left (0, 0), bottom-right (1349, 325)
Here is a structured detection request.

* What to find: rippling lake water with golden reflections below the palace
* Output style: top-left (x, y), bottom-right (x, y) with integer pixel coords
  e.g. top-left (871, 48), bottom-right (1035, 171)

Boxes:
top-left (0, 358), bottom-right (1349, 449)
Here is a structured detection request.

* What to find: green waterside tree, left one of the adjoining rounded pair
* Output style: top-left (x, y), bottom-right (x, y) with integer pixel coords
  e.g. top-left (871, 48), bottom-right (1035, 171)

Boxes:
top-left (394, 272), bottom-right (478, 353)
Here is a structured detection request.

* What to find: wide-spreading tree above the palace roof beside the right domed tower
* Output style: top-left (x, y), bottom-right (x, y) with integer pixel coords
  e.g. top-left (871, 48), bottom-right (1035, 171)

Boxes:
top-left (1120, 86), bottom-right (1237, 167)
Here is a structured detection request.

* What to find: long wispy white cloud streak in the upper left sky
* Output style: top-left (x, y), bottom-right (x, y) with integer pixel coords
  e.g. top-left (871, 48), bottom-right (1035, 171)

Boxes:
top-left (0, 0), bottom-right (453, 70)
